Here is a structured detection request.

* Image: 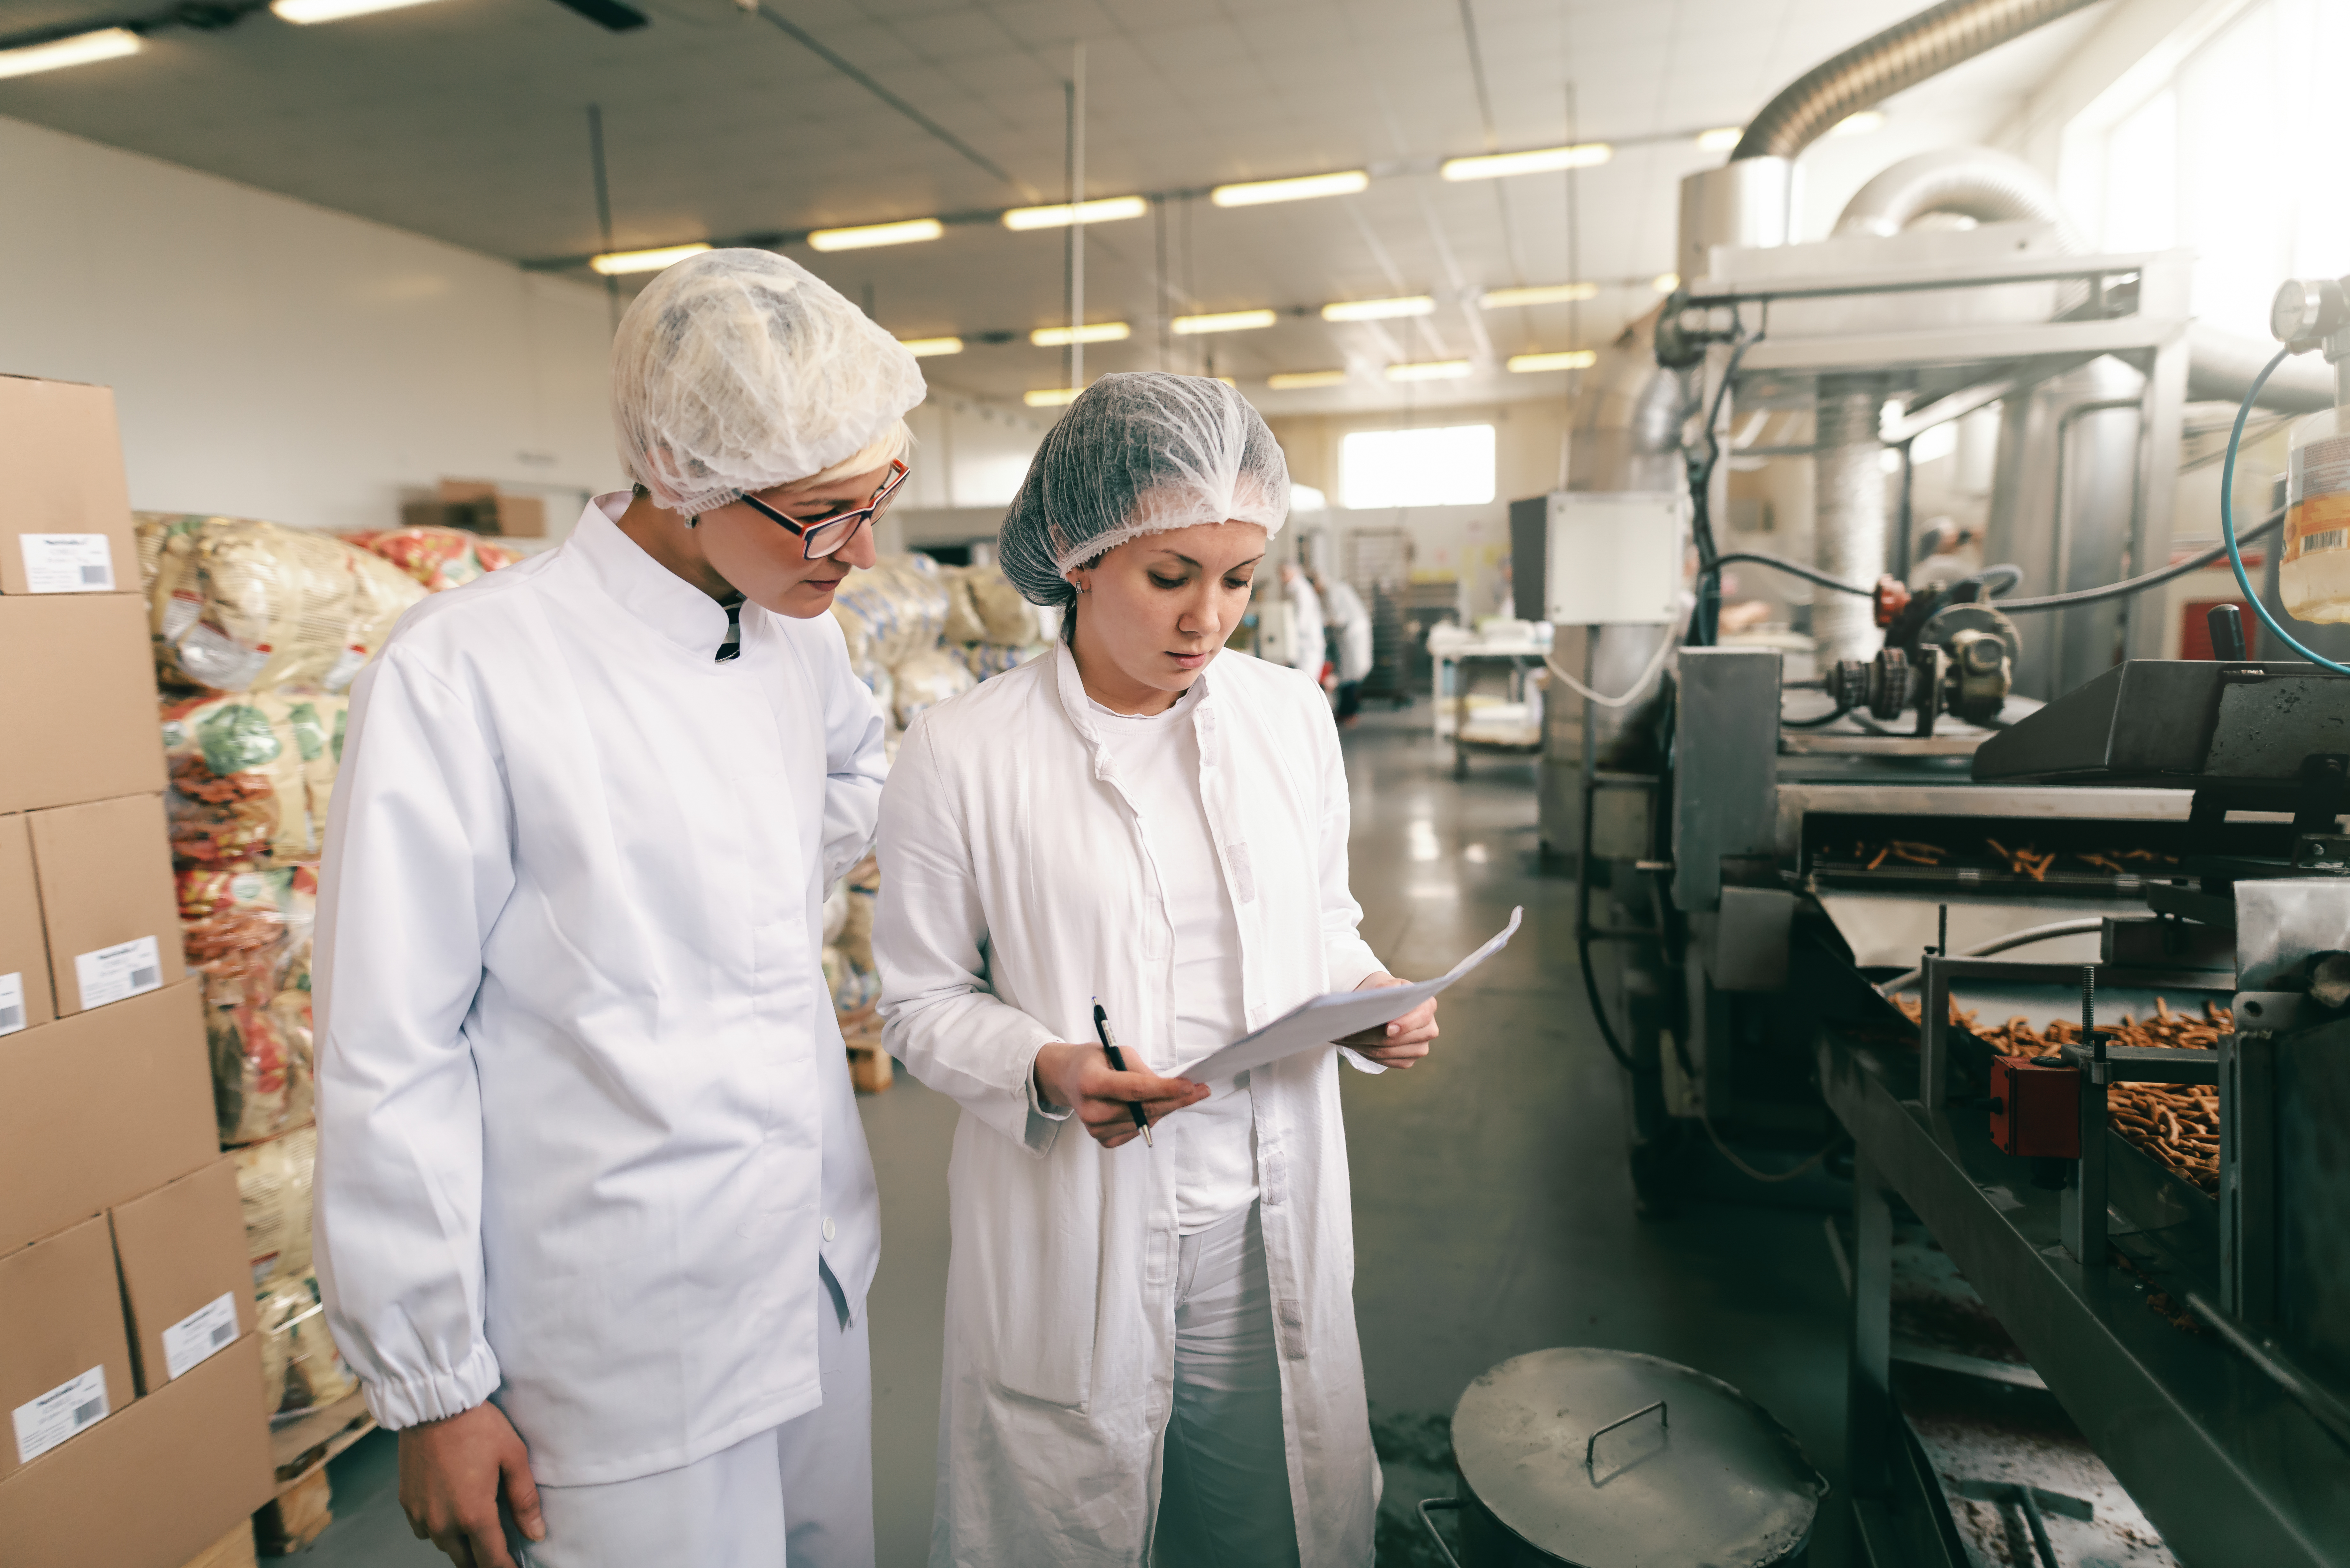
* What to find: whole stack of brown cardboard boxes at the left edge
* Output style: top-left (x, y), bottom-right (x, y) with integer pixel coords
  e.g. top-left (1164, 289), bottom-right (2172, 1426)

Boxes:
top-left (0, 376), bottom-right (273, 1568)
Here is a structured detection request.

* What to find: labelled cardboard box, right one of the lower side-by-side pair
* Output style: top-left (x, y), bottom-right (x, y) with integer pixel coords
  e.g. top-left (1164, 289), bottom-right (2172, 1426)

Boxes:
top-left (108, 1157), bottom-right (254, 1394)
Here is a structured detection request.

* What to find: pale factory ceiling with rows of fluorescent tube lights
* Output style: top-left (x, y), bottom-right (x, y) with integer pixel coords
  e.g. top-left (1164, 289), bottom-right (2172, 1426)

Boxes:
top-left (0, 0), bottom-right (2103, 411)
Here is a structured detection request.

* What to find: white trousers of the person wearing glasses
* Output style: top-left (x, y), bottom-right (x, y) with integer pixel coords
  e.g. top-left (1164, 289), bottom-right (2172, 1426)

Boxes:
top-left (524, 1265), bottom-right (874, 1568)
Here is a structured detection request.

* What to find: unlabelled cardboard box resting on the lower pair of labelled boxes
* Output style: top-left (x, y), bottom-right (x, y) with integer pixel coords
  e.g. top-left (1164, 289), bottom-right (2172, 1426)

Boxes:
top-left (0, 983), bottom-right (221, 1251)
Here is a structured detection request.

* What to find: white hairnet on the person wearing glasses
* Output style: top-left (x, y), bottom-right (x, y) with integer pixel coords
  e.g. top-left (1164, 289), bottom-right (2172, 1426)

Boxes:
top-left (611, 249), bottom-right (923, 512)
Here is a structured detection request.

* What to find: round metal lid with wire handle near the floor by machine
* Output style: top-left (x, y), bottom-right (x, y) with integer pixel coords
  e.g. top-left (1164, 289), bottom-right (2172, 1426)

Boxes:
top-left (1452, 1347), bottom-right (1828, 1568)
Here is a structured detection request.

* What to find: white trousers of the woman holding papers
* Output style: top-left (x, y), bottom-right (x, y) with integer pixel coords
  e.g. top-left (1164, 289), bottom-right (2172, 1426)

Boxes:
top-left (1151, 1204), bottom-right (1297, 1568)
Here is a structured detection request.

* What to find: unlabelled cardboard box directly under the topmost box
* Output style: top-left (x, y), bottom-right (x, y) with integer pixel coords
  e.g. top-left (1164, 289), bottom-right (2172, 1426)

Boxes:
top-left (0, 595), bottom-right (164, 811)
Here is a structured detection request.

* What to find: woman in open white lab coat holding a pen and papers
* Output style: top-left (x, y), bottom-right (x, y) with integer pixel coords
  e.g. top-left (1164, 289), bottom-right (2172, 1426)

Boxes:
top-left (874, 374), bottom-right (1436, 1568)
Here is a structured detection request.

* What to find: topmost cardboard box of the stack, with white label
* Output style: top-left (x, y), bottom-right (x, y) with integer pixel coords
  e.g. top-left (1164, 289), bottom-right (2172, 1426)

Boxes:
top-left (0, 376), bottom-right (139, 595)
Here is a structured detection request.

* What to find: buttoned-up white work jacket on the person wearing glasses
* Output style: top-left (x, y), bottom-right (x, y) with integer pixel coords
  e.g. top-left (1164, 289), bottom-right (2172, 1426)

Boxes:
top-left (317, 494), bottom-right (883, 1486)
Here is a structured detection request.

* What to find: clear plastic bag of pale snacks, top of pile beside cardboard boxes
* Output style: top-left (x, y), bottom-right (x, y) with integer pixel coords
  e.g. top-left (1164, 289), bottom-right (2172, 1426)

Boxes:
top-left (139, 512), bottom-right (425, 691)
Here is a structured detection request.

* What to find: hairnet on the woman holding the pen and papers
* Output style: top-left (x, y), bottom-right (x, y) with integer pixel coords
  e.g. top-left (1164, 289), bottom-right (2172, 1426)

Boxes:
top-left (997, 372), bottom-right (1290, 604)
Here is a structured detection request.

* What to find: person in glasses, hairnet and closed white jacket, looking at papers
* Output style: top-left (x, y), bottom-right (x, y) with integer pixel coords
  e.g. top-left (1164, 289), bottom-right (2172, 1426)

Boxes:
top-left (303, 249), bottom-right (923, 1568)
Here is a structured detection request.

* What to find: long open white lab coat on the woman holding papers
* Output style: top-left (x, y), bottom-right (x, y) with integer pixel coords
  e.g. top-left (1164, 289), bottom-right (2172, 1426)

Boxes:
top-left (874, 649), bottom-right (1379, 1568)
